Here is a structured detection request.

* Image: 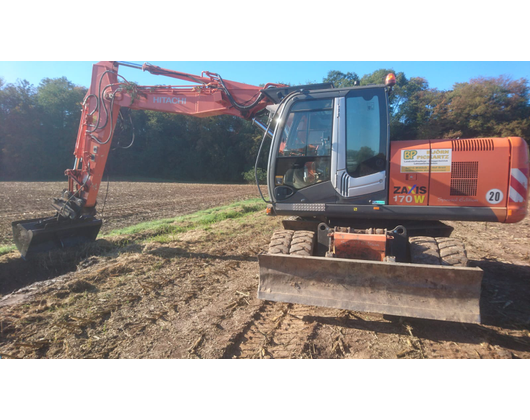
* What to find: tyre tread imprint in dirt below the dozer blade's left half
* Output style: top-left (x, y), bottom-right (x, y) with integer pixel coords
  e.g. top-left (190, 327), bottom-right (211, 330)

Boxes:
top-left (222, 301), bottom-right (319, 359)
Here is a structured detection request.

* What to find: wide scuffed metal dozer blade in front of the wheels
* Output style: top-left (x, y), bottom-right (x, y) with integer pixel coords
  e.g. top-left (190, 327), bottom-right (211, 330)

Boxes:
top-left (258, 254), bottom-right (483, 323)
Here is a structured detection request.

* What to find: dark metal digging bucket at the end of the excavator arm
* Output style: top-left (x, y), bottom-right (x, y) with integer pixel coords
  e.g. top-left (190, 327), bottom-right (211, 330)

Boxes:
top-left (11, 217), bottom-right (102, 259)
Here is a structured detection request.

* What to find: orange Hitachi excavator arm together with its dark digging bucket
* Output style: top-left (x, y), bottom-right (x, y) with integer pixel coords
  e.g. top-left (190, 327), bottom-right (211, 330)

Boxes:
top-left (12, 61), bottom-right (284, 258)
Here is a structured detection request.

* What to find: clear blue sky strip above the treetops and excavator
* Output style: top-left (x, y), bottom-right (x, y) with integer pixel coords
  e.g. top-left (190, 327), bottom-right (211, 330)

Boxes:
top-left (0, 60), bottom-right (530, 90)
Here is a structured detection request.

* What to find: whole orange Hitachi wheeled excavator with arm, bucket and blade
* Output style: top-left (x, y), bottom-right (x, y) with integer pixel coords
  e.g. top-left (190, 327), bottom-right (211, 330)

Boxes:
top-left (12, 61), bottom-right (529, 323)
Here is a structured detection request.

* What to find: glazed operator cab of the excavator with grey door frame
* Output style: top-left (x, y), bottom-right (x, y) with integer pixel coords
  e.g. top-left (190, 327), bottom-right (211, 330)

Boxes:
top-left (268, 86), bottom-right (389, 210)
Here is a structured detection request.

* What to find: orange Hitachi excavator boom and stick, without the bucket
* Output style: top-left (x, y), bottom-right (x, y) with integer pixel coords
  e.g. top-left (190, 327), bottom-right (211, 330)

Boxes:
top-left (65, 62), bottom-right (276, 212)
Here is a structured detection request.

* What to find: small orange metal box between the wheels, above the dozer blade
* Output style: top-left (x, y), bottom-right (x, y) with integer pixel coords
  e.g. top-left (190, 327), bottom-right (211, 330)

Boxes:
top-left (333, 232), bottom-right (386, 261)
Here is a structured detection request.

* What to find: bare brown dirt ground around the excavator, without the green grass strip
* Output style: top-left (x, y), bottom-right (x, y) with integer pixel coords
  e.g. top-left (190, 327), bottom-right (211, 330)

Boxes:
top-left (0, 183), bottom-right (530, 359)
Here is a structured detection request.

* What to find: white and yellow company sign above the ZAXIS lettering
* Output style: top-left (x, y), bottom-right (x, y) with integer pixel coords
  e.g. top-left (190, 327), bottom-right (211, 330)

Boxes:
top-left (401, 149), bottom-right (452, 173)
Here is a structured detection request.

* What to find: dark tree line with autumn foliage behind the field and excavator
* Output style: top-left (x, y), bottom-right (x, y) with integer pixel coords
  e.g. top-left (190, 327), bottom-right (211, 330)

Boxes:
top-left (0, 69), bottom-right (530, 182)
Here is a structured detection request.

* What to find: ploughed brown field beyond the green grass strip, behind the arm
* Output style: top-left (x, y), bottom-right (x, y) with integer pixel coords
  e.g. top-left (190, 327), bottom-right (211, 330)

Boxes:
top-left (0, 182), bottom-right (258, 246)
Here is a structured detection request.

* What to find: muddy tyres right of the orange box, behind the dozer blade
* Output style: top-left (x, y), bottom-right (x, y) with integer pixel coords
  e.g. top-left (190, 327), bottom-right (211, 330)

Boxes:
top-left (409, 236), bottom-right (468, 267)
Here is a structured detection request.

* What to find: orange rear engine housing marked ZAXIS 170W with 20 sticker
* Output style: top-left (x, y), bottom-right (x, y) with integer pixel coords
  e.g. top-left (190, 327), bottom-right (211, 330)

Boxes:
top-left (388, 137), bottom-right (529, 223)
